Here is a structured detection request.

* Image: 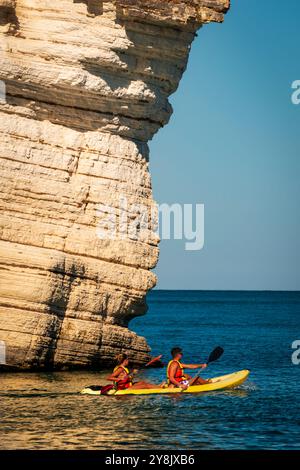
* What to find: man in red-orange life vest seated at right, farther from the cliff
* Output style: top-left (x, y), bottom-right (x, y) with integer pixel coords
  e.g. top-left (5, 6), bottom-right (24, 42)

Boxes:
top-left (167, 348), bottom-right (209, 390)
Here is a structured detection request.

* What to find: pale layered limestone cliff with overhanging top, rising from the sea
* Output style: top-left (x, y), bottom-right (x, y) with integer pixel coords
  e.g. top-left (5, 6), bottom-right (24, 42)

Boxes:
top-left (0, 0), bottom-right (229, 369)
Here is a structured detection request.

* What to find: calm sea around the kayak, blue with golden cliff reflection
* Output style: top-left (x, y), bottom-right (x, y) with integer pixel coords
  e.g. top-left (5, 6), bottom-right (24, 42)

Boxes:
top-left (0, 290), bottom-right (300, 450)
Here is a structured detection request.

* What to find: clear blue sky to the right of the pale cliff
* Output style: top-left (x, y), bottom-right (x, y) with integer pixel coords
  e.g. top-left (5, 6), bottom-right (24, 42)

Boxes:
top-left (150, 0), bottom-right (300, 290)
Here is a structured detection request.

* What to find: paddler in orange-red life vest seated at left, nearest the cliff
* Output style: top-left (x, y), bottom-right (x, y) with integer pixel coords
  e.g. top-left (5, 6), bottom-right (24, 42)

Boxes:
top-left (107, 353), bottom-right (159, 390)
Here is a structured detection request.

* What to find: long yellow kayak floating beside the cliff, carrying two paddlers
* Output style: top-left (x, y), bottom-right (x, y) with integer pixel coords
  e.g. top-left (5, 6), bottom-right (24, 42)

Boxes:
top-left (80, 370), bottom-right (250, 396)
